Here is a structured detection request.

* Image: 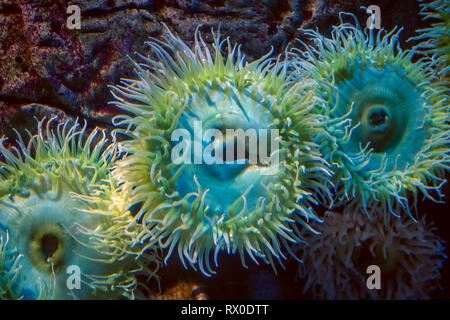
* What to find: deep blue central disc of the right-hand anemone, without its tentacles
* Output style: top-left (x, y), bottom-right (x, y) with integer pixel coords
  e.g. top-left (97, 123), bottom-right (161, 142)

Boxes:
top-left (336, 62), bottom-right (426, 170)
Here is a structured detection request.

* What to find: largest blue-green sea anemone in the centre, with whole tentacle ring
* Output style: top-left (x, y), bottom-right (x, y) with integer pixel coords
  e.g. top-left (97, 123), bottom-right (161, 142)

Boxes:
top-left (113, 30), bottom-right (330, 276)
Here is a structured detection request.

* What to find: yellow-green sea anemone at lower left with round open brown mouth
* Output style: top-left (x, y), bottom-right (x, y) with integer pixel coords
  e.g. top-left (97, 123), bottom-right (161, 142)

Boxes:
top-left (0, 119), bottom-right (158, 299)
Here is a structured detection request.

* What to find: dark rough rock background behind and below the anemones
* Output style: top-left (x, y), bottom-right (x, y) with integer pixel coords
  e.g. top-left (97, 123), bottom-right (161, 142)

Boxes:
top-left (0, 0), bottom-right (449, 299)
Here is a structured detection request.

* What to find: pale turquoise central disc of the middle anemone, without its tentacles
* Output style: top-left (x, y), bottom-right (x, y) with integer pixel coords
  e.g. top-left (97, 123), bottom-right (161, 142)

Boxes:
top-left (177, 85), bottom-right (273, 212)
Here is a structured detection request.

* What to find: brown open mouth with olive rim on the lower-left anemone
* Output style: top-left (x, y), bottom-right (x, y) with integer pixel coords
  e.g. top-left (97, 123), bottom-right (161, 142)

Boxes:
top-left (29, 224), bottom-right (67, 274)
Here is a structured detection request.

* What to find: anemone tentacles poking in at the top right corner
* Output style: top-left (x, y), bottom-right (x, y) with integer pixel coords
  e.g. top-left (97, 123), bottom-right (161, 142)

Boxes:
top-left (413, 0), bottom-right (450, 75)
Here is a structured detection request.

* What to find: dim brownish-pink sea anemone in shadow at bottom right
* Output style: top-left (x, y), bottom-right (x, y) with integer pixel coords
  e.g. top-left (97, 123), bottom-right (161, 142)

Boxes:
top-left (300, 211), bottom-right (447, 299)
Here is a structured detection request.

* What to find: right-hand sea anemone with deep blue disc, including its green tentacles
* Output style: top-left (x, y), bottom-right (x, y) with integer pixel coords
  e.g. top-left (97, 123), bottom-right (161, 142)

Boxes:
top-left (293, 14), bottom-right (450, 219)
